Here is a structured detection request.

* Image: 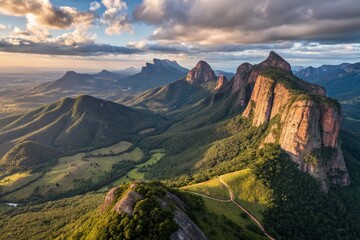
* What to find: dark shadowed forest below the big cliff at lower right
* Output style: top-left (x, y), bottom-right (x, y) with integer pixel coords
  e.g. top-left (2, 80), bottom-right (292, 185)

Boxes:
top-left (253, 143), bottom-right (360, 239)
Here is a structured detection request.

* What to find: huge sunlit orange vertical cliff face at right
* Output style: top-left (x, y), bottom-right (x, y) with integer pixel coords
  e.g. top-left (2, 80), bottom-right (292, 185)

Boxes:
top-left (243, 73), bottom-right (349, 191)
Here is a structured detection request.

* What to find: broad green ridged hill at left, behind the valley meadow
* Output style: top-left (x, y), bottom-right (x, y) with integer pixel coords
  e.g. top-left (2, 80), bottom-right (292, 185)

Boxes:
top-left (0, 95), bottom-right (163, 172)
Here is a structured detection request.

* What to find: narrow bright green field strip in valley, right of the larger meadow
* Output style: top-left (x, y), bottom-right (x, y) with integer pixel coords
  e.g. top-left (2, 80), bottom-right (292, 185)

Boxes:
top-left (99, 149), bottom-right (165, 192)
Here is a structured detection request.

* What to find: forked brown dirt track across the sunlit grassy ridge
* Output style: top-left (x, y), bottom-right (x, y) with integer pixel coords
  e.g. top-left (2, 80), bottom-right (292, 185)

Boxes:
top-left (188, 177), bottom-right (275, 240)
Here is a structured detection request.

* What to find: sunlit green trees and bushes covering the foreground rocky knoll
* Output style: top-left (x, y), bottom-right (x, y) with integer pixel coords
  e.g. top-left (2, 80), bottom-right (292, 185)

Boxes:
top-left (64, 182), bottom-right (178, 240)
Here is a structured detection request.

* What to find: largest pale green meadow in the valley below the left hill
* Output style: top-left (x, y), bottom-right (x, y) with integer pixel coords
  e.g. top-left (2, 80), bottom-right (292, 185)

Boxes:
top-left (3, 147), bottom-right (144, 202)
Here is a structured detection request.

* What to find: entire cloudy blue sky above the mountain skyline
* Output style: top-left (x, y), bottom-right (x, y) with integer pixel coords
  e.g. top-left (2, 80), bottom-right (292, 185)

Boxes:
top-left (0, 0), bottom-right (360, 71)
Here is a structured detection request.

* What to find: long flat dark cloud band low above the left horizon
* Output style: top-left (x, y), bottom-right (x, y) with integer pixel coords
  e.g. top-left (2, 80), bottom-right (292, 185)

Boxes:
top-left (0, 38), bottom-right (143, 56)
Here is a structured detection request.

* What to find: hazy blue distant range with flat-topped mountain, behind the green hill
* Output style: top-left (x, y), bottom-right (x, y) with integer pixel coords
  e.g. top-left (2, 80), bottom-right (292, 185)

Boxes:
top-left (14, 59), bottom-right (187, 103)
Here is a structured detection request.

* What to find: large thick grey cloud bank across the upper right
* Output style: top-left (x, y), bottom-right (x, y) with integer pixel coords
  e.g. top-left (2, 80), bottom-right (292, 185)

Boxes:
top-left (133, 0), bottom-right (360, 45)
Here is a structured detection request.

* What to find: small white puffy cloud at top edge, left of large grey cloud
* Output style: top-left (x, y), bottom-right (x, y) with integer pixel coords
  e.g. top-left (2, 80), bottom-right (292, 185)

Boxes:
top-left (101, 0), bottom-right (132, 35)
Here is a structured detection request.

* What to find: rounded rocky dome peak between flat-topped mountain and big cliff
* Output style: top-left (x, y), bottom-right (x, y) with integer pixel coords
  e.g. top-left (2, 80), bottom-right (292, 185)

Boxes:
top-left (186, 61), bottom-right (217, 84)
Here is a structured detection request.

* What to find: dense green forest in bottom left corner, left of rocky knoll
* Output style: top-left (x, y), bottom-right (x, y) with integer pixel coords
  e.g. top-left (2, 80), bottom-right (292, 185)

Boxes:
top-left (0, 194), bottom-right (104, 240)
